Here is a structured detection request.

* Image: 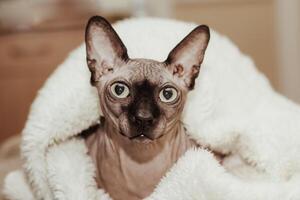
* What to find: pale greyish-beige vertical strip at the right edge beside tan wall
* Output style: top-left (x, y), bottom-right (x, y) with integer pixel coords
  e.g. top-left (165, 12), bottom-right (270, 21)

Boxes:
top-left (276, 0), bottom-right (300, 103)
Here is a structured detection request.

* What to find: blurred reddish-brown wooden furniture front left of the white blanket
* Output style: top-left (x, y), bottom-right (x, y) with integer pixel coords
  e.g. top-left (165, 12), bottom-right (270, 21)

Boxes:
top-left (0, 29), bottom-right (83, 140)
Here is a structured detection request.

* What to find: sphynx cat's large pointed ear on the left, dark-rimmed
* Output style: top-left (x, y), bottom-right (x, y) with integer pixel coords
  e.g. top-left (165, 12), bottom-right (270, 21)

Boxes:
top-left (85, 16), bottom-right (128, 84)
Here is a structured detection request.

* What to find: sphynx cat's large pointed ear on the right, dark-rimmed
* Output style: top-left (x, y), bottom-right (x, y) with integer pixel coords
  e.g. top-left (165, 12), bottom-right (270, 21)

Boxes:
top-left (165, 25), bottom-right (210, 89)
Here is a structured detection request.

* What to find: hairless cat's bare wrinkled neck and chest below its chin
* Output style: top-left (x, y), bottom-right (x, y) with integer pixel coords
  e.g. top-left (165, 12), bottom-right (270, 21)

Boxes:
top-left (86, 119), bottom-right (196, 200)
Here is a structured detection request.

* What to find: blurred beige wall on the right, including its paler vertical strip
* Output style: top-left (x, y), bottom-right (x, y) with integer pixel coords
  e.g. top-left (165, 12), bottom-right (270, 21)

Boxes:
top-left (172, 0), bottom-right (300, 103)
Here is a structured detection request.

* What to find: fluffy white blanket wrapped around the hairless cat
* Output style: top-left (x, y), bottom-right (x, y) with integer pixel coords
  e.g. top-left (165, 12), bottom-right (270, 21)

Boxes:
top-left (4, 18), bottom-right (300, 200)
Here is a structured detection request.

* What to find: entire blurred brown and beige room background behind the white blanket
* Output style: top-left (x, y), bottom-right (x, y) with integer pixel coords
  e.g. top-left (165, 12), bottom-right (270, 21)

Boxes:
top-left (0, 0), bottom-right (300, 190)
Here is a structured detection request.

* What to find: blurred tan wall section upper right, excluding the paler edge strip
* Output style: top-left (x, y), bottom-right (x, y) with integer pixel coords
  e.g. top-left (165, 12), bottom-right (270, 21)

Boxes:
top-left (174, 0), bottom-right (279, 88)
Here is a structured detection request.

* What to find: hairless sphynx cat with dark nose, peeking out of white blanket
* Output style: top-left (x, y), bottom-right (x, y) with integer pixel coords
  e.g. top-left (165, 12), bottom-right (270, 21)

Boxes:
top-left (85, 17), bottom-right (213, 200)
